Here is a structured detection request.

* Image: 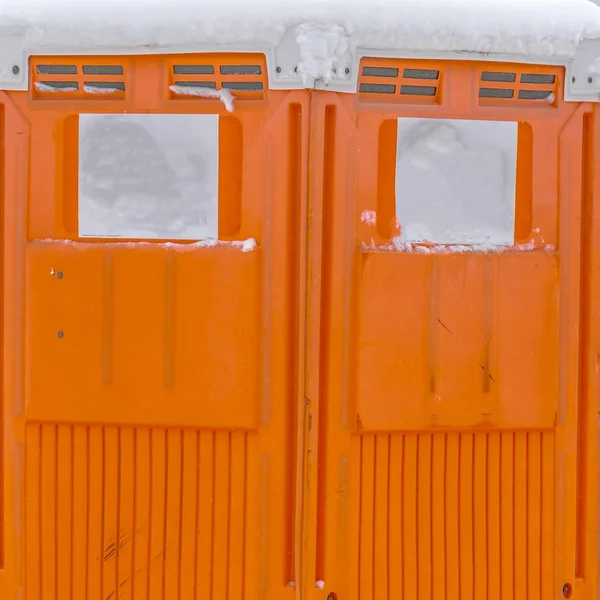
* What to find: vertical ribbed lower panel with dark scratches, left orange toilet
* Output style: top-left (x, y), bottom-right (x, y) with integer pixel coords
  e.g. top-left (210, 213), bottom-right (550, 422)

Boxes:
top-left (25, 424), bottom-right (248, 600)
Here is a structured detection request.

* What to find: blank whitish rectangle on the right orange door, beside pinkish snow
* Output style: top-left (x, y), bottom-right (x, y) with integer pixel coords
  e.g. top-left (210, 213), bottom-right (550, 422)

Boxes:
top-left (396, 118), bottom-right (517, 244)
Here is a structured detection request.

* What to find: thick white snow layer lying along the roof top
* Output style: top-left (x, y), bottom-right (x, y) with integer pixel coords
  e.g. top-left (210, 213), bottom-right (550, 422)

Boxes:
top-left (0, 0), bottom-right (600, 60)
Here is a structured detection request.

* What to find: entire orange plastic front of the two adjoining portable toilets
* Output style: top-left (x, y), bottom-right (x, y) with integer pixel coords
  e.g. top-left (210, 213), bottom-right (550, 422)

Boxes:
top-left (0, 54), bottom-right (600, 600)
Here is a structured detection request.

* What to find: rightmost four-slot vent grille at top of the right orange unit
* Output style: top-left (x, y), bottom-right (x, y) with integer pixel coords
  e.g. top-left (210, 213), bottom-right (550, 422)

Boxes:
top-left (479, 70), bottom-right (558, 105)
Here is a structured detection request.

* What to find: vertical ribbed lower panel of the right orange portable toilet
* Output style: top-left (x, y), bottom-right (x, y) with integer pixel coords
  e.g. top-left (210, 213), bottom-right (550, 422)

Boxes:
top-left (356, 432), bottom-right (554, 600)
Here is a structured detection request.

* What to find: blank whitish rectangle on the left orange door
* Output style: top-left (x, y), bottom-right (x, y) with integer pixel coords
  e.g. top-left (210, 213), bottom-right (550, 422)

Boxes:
top-left (79, 115), bottom-right (219, 240)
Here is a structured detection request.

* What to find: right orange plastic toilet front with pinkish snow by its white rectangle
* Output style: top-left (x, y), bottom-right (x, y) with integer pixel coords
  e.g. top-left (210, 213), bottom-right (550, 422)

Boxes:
top-left (304, 59), bottom-right (600, 600)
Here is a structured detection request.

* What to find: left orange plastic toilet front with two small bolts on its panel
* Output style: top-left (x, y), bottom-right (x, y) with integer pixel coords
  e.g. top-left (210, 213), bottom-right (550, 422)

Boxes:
top-left (0, 55), bottom-right (308, 600)
